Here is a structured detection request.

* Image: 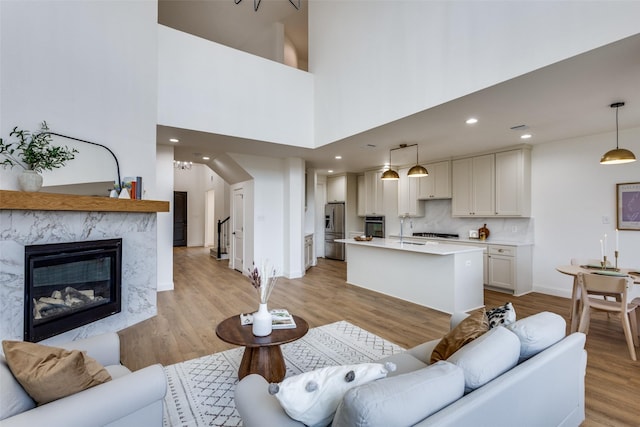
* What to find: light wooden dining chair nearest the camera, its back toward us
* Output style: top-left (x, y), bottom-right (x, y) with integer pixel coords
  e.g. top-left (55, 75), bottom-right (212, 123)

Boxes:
top-left (577, 273), bottom-right (639, 361)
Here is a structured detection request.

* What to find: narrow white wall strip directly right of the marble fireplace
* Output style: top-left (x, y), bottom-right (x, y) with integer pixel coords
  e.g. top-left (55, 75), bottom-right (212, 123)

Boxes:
top-left (156, 145), bottom-right (173, 291)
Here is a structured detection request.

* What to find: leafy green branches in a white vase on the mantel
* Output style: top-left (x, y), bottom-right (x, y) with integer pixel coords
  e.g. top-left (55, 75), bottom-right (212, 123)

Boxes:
top-left (0, 121), bottom-right (78, 191)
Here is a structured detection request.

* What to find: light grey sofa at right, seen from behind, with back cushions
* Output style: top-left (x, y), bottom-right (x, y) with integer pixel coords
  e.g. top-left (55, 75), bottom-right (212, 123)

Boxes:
top-left (235, 312), bottom-right (587, 427)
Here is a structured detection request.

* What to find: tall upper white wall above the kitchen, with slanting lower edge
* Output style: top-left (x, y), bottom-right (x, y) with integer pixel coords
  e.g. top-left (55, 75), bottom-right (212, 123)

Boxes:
top-left (309, 0), bottom-right (640, 146)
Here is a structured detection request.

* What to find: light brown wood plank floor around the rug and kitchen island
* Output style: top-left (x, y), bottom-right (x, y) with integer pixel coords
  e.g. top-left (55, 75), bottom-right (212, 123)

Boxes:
top-left (120, 248), bottom-right (640, 427)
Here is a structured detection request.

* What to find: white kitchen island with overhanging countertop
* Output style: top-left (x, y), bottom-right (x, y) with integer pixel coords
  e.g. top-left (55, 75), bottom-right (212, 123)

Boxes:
top-left (337, 239), bottom-right (484, 314)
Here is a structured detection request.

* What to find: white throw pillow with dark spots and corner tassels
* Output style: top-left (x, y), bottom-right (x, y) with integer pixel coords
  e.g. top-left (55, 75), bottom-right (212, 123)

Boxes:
top-left (269, 363), bottom-right (395, 427)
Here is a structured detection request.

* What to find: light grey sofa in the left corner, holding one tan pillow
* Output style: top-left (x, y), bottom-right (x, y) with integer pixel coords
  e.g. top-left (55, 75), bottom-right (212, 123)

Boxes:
top-left (0, 333), bottom-right (167, 427)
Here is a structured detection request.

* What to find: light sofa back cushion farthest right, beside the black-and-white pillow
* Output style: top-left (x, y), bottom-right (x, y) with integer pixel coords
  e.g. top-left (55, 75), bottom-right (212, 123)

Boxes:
top-left (507, 311), bottom-right (567, 362)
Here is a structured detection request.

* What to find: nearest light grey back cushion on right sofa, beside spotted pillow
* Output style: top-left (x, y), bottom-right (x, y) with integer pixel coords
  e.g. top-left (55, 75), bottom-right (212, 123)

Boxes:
top-left (332, 361), bottom-right (464, 427)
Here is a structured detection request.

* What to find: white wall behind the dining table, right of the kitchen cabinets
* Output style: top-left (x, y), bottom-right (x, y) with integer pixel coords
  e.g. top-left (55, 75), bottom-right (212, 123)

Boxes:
top-left (532, 128), bottom-right (640, 297)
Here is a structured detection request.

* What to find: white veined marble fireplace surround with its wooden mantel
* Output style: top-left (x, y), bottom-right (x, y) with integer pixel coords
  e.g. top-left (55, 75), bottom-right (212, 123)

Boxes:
top-left (0, 190), bottom-right (169, 344)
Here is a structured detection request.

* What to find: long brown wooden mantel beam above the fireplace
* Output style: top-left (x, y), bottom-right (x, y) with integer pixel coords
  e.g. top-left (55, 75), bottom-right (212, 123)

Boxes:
top-left (0, 190), bottom-right (169, 212)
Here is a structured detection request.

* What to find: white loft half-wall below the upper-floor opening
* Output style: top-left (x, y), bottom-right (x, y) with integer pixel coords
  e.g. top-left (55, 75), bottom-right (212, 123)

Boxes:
top-left (157, 25), bottom-right (314, 147)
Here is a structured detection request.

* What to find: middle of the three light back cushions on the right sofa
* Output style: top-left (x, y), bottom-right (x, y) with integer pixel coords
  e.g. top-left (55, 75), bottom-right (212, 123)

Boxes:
top-left (447, 326), bottom-right (520, 393)
